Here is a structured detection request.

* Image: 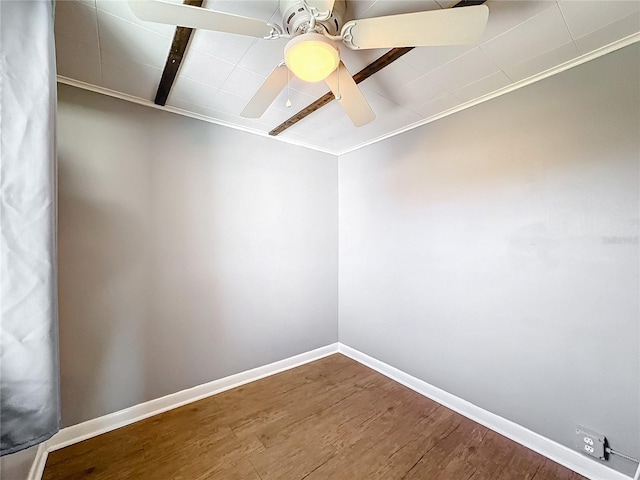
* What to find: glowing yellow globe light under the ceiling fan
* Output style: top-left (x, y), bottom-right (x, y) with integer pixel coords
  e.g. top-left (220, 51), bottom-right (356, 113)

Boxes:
top-left (284, 33), bottom-right (340, 82)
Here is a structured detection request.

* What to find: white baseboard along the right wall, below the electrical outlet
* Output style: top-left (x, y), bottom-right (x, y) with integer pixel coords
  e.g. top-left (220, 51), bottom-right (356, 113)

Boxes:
top-left (338, 343), bottom-right (631, 480)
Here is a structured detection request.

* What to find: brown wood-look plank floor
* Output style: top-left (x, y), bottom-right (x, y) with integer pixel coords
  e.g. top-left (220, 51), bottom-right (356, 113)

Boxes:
top-left (43, 354), bottom-right (584, 480)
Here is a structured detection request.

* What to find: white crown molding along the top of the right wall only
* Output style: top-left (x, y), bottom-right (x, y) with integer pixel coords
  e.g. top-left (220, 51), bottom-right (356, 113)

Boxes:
top-left (337, 32), bottom-right (640, 156)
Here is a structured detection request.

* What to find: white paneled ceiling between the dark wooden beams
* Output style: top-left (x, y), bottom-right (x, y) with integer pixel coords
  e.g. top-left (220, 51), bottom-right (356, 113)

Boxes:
top-left (55, 0), bottom-right (640, 154)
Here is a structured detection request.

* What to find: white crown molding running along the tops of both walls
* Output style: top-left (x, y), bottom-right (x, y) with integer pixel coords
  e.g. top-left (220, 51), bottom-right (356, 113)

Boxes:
top-left (57, 33), bottom-right (640, 156)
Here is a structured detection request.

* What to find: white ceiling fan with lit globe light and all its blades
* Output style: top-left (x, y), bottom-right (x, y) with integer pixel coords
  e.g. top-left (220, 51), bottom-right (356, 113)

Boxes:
top-left (129, 0), bottom-right (489, 127)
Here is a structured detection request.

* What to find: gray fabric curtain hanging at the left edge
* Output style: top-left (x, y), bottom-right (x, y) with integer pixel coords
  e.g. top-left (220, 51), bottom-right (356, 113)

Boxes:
top-left (0, 0), bottom-right (60, 455)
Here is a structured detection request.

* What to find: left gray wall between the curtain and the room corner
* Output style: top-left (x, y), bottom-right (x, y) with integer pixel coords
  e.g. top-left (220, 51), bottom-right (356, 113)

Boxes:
top-left (58, 85), bottom-right (337, 426)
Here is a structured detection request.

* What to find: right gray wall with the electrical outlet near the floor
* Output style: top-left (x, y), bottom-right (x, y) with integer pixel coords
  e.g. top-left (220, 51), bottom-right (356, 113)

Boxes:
top-left (339, 45), bottom-right (640, 474)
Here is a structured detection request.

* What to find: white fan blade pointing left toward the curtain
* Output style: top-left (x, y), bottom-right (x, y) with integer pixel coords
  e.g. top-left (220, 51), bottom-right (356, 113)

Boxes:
top-left (129, 0), bottom-right (280, 38)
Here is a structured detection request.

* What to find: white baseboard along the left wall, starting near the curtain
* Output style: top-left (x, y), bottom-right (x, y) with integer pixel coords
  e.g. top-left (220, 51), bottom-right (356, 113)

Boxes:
top-left (45, 343), bottom-right (338, 452)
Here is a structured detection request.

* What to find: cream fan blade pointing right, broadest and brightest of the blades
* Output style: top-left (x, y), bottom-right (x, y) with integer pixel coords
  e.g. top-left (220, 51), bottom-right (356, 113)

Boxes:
top-left (342, 5), bottom-right (489, 50)
